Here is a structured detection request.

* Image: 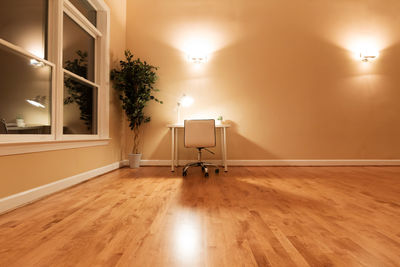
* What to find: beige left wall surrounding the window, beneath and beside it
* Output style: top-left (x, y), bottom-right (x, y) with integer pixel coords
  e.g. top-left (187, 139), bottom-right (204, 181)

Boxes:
top-left (0, 0), bottom-right (126, 198)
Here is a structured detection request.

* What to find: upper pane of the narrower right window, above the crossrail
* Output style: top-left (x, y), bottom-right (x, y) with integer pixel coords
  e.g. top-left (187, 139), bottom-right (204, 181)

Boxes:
top-left (63, 14), bottom-right (94, 82)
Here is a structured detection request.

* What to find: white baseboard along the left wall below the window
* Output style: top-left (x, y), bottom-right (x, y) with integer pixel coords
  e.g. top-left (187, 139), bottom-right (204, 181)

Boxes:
top-left (0, 162), bottom-right (123, 214)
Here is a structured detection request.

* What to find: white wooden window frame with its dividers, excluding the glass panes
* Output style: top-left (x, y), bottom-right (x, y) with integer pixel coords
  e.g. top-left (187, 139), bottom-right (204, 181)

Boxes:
top-left (0, 0), bottom-right (110, 156)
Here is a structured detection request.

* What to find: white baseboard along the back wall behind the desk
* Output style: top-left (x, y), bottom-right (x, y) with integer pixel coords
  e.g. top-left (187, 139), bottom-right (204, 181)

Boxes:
top-left (134, 159), bottom-right (400, 166)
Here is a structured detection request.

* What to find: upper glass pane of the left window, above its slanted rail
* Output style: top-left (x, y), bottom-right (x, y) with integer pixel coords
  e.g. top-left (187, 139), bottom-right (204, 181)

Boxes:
top-left (0, 0), bottom-right (47, 58)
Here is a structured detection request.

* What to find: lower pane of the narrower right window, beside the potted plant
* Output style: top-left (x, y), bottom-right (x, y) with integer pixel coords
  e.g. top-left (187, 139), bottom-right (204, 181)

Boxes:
top-left (63, 74), bottom-right (97, 134)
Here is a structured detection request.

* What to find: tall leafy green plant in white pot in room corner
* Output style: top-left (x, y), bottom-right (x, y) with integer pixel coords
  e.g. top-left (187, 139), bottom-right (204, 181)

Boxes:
top-left (111, 50), bottom-right (163, 168)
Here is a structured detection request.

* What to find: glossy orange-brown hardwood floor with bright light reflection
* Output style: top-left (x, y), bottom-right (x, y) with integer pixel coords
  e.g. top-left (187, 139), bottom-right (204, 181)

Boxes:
top-left (0, 167), bottom-right (400, 267)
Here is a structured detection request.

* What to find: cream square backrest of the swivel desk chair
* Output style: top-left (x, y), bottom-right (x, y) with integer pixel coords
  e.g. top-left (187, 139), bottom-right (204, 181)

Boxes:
top-left (184, 120), bottom-right (215, 148)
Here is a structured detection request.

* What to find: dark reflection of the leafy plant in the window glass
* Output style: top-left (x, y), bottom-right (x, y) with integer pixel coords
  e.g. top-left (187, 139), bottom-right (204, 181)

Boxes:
top-left (64, 50), bottom-right (93, 131)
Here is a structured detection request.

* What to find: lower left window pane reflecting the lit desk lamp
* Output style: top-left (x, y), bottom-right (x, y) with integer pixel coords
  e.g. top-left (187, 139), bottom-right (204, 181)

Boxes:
top-left (0, 45), bottom-right (52, 134)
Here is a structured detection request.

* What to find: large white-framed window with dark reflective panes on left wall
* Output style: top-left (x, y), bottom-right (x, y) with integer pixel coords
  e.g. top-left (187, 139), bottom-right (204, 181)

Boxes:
top-left (0, 0), bottom-right (109, 155)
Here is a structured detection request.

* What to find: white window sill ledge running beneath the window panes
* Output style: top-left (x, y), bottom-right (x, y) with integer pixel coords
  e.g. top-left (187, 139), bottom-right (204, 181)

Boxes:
top-left (0, 138), bottom-right (111, 156)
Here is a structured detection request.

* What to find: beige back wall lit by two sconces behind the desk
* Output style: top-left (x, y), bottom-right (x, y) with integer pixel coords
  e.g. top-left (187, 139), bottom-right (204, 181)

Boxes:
top-left (126, 0), bottom-right (400, 159)
